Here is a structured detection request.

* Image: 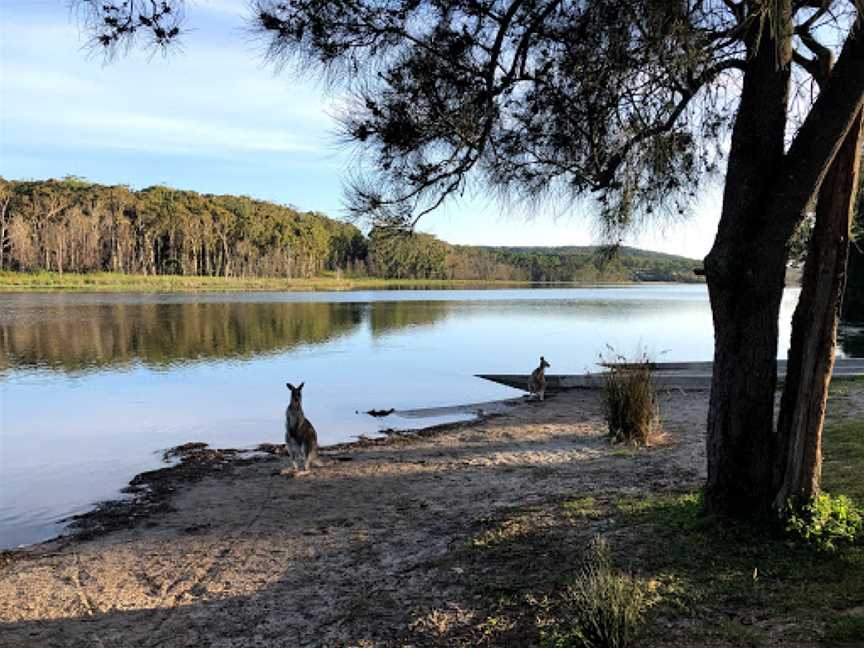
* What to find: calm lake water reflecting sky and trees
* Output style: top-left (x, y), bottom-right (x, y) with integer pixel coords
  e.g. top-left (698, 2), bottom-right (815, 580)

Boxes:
top-left (0, 285), bottom-right (797, 547)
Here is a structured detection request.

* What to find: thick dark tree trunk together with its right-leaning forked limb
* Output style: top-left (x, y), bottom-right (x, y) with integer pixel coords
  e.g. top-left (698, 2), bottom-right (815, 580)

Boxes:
top-left (705, 3), bottom-right (864, 518)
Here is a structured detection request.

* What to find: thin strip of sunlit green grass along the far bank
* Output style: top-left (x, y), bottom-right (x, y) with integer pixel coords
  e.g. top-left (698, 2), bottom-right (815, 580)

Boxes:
top-left (0, 271), bottom-right (529, 292)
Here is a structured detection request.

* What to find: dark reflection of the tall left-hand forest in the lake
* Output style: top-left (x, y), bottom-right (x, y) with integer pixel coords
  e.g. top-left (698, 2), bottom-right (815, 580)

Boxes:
top-left (0, 303), bottom-right (364, 372)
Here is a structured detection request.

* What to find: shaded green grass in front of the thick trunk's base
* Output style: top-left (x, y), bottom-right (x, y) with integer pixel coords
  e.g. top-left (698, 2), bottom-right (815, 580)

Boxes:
top-left (618, 494), bottom-right (864, 645)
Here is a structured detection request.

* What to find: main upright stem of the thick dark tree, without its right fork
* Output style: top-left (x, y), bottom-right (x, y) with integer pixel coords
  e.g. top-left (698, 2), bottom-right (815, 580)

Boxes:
top-left (705, 3), bottom-right (792, 518)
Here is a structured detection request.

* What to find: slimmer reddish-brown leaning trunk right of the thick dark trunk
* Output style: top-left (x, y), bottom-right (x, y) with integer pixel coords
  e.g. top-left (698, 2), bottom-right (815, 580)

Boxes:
top-left (774, 112), bottom-right (862, 511)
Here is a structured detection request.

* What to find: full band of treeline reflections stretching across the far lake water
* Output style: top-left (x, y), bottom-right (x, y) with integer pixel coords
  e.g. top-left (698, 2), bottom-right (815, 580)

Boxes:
top-left (0, 295), bottom-right (705, 373)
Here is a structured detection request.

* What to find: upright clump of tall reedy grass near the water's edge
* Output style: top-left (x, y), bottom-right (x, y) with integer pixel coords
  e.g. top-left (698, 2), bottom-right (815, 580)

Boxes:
top-left (601, 352), bottom-right (660, 445)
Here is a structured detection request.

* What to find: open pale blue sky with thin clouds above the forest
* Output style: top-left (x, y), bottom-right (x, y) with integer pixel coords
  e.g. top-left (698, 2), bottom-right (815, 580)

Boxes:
top-left (0, 0), bottom-right (720, 257)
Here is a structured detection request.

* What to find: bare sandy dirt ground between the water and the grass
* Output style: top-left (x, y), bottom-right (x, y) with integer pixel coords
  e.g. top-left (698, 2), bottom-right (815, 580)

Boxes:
top-left (0, 391), bottom-right (768, 648)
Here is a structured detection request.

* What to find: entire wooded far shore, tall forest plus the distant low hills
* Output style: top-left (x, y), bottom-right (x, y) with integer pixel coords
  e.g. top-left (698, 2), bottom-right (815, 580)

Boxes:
top-left (0, 177), bottom-right (700, 282)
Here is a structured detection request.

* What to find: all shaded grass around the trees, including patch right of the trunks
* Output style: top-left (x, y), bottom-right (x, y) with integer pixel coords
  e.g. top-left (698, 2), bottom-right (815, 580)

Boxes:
top-left (588, 419), bottom-right (864, 645)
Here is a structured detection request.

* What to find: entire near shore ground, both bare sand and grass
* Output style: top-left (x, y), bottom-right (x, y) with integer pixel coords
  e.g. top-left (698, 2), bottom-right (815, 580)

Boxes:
top-left (0, 381), bottom-right (864, 648)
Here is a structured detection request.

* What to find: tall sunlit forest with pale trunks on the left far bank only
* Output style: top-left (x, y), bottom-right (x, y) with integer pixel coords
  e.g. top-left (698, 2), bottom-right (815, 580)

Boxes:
top-left (0, 178), bottom-right (366, 277)
